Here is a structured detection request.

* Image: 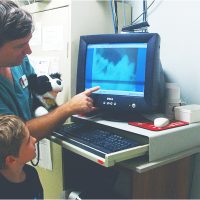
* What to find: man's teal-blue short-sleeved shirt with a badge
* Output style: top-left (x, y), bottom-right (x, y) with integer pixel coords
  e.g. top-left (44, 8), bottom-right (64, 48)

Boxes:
top-left (0, 56), bottom-right (35, 121)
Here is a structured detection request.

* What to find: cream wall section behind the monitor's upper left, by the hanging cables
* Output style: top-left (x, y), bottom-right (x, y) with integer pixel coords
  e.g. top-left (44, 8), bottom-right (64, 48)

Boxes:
top-left (71, 0), bottom-right (131, 96)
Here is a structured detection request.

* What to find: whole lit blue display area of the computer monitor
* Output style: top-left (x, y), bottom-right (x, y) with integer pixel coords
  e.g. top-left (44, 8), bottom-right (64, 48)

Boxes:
top-left (86, 44), bottom-right (146, 95)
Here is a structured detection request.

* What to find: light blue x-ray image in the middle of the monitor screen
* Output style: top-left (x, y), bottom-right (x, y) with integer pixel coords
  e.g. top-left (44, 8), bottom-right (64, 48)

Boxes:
top-left (92, 48), bottom-right (136, 90)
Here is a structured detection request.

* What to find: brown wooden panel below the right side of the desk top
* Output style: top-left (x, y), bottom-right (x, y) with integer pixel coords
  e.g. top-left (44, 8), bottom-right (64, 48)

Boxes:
top-left (121, 156), bottom-right (193, 199)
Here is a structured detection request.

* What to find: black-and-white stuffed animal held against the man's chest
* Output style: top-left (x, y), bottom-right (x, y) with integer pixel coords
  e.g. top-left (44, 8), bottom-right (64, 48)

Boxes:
top-left (28, 73), bottom-right (63, 117)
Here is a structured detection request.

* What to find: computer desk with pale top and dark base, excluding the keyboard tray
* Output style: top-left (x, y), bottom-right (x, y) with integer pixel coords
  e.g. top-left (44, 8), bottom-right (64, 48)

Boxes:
top-left (51, 117), bottom-right (200, 199)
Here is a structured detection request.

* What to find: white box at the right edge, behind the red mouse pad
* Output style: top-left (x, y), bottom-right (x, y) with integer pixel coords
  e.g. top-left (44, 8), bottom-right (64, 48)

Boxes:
top-left (174, 104), bottom-right (200, 123)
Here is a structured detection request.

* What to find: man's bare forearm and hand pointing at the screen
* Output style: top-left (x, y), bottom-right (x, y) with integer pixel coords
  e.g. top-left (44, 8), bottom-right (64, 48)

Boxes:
top-left (26, 87), bottom-right (99, 140)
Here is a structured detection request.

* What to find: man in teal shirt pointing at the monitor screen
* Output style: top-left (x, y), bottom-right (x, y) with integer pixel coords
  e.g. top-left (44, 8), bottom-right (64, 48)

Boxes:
top-left (0, 0), bottom-right (99, 140)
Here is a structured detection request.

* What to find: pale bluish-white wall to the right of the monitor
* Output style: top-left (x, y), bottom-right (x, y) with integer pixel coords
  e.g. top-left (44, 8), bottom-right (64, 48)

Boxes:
top-left (145, 0), bottom-right (200, 198)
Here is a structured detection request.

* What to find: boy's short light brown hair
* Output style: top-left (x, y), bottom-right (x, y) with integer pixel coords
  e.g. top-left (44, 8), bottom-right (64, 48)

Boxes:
top-left (0, 115), bottom-right (25, 169)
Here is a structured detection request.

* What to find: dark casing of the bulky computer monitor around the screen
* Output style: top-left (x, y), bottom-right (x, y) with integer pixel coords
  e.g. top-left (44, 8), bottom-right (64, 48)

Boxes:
top-left (76, 33), bottom-right (164, 114)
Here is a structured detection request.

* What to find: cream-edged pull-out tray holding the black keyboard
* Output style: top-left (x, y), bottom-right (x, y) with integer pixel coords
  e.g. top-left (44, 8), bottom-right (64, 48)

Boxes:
top-left (50, 124), bottom-right (149, 167)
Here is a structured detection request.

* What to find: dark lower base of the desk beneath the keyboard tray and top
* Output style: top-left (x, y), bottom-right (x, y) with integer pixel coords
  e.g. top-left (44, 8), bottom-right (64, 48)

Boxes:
top-left (63, 150), bottom-right (193, 199)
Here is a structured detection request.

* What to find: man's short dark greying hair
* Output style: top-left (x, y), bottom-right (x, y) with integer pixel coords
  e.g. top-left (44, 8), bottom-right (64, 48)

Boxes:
top-left (0, 0), bottom-right (34, 47)
